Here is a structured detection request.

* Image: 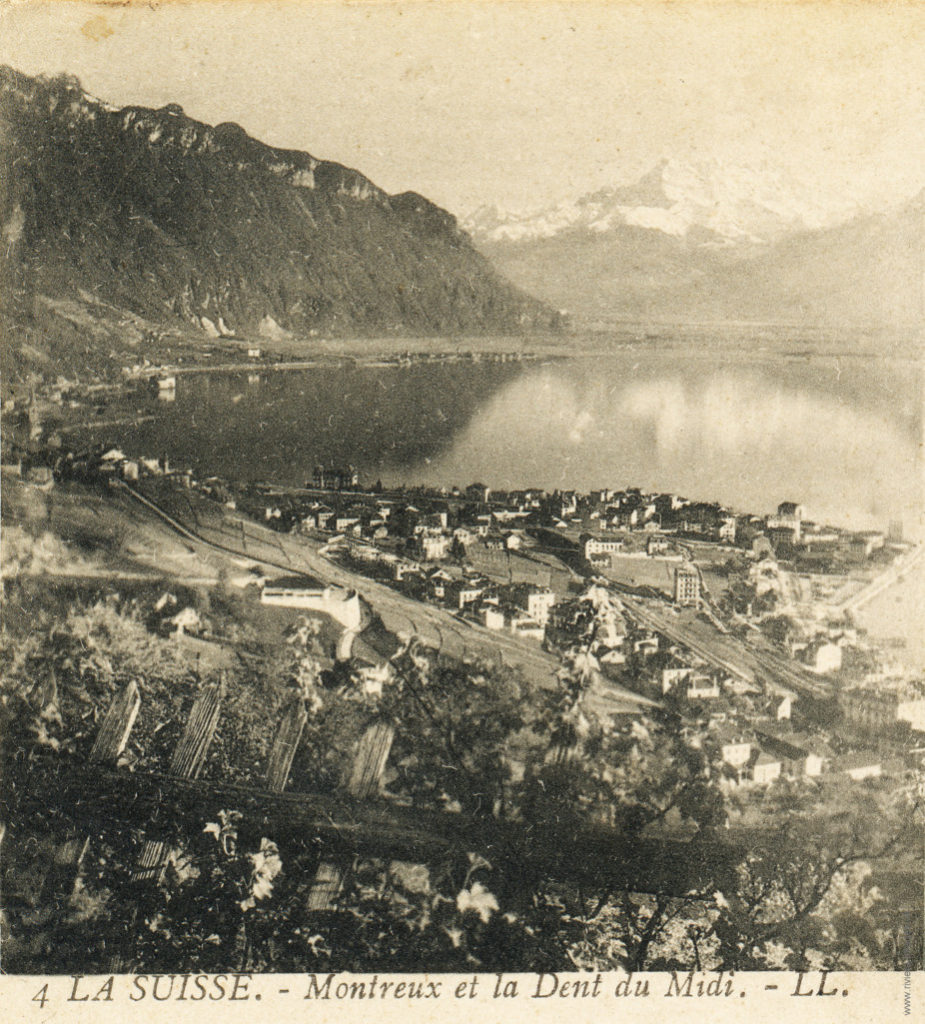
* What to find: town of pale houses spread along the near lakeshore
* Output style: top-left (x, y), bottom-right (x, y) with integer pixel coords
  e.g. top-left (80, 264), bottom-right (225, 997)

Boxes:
top-left (4, 399), bottom-right (925, 806)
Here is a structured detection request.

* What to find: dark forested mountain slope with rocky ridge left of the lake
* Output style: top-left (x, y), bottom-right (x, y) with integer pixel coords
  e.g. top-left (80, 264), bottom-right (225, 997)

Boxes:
top-left (0, 68), bottom-right (550, 374)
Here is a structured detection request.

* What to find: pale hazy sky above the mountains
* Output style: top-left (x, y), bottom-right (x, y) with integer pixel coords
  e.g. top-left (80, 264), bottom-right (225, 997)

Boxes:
top-left (0, 0), bottom-right (925, 214)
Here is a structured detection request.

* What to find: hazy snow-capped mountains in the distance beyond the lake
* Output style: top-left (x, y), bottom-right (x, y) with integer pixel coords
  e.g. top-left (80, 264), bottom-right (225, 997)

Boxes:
top-left (471, 161), bottom-right (925, 328)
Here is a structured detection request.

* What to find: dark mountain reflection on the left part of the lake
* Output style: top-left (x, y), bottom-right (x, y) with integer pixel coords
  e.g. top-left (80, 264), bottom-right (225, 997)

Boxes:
top-left (122, 362), bottom-right (521, 486)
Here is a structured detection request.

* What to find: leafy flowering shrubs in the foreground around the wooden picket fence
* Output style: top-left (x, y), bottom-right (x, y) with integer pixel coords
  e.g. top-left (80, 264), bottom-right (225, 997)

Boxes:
top-left (0, 585), bottom-right (922, 972)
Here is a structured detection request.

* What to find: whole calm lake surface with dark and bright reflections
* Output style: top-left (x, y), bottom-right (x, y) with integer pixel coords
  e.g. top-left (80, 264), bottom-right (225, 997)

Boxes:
top-left (115, 349), bottom-right (923, 536)
